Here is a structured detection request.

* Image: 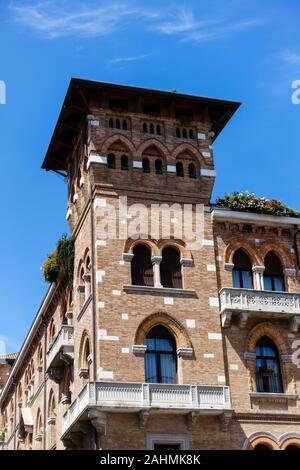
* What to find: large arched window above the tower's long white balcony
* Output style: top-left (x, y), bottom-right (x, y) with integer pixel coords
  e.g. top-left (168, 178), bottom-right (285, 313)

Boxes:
top-left (145, 326), bottom-right (177, 384)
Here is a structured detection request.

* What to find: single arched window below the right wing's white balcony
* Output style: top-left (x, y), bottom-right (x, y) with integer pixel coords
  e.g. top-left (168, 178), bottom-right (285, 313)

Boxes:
top-left (255, 336), bottom-right (283, 393)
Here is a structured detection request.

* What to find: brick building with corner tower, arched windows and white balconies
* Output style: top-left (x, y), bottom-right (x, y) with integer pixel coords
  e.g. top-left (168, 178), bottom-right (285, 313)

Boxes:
top-left (0, 79), bottom-right (300, 450)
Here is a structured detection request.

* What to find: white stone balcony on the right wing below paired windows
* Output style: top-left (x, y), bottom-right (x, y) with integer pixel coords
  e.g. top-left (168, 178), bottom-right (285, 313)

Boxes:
top-left (219, 287), bottom-right (300, 332)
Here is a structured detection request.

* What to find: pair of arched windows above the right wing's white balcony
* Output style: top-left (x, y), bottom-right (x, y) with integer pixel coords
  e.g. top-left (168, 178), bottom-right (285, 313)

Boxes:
top-left (232, 249), bottom-right (285, 292)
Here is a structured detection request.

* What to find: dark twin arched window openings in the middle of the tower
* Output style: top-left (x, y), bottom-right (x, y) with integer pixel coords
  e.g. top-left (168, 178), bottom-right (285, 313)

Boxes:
top-left (131, 244), bottom-right (182, 289)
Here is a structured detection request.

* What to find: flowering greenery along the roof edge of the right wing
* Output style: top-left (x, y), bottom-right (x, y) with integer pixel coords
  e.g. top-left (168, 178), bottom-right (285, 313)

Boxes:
top-left (216, 191), bottom-right (300, 217)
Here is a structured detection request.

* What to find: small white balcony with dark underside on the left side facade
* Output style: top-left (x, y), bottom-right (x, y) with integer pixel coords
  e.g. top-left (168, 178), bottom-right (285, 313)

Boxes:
top-left (46, 325), bottom-right (74, 383)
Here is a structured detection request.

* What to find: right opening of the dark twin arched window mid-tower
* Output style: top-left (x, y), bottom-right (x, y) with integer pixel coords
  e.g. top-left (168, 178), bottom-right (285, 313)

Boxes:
top-left (160, 247), bottom-right (182, 289)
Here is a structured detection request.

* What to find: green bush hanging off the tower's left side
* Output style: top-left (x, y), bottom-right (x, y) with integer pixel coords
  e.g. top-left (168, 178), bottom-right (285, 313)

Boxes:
top-left (43, 234), bottom-right (74, 285)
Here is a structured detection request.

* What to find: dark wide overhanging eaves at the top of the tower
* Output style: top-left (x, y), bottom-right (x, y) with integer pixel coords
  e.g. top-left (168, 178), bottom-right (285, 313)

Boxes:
top-left (42, 78), bottom-right (240, 171)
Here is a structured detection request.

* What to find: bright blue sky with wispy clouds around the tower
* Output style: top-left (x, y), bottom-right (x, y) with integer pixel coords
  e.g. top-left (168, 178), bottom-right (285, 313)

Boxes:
top-left (0, 0), bottom-right (300, 351)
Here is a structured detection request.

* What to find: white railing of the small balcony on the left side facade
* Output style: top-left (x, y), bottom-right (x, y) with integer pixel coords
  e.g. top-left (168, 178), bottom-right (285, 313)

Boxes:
top-left (46, 325), bottom-right (74, 370)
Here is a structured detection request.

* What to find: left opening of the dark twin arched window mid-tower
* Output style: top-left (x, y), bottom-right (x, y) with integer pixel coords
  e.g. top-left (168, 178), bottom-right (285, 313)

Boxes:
top-left (131, 245), bottom-right (153, 286)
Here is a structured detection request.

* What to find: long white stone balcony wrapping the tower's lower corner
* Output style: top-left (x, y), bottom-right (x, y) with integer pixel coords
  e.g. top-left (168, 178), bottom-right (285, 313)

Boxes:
top-left (62, 382), bottom-right (232, 435)
